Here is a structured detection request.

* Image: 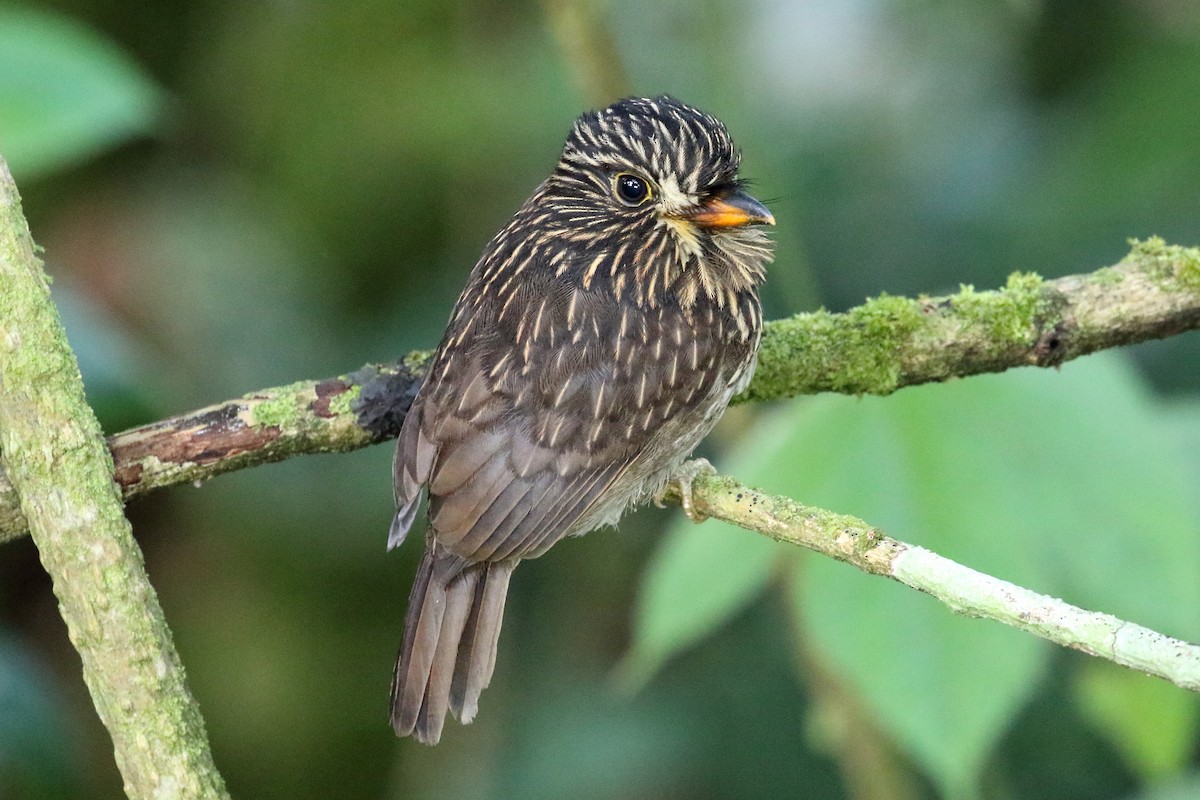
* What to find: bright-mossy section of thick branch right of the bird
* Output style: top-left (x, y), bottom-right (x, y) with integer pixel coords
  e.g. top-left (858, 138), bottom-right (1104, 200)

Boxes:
top-left (739, 237), bottom-right (1200, 401)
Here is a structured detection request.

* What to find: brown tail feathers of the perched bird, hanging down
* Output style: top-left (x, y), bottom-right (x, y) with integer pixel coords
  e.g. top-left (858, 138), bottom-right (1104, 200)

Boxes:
top-left (391, 542), bottom-right (516, 745)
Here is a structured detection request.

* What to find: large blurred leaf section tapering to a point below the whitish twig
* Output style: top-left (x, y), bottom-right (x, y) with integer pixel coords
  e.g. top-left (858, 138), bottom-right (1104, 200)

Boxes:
top-left (791, 554), bottom-right (1046, 798)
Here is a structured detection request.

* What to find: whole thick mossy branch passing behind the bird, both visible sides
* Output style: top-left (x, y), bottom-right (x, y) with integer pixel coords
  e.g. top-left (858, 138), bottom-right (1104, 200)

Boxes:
top-left (0, 239), bottom-right (1200, 542)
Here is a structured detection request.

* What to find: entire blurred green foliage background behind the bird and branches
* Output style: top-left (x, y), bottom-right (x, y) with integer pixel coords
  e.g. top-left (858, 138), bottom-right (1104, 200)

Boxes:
top-left (0, 0), bottom-right (1200, 800)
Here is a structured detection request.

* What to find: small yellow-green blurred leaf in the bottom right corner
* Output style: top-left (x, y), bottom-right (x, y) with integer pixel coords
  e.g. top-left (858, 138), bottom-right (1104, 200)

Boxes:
top-left (1075, 660), bottom-right (1200, 781)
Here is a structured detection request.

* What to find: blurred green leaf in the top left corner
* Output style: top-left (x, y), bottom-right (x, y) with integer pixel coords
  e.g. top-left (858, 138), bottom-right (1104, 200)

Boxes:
top-left (0, 7), bottom-right (163, 178)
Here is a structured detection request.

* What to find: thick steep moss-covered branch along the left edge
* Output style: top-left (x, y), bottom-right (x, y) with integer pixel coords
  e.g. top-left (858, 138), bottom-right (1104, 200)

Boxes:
top-left (0, 158), bottom-right (227, 799)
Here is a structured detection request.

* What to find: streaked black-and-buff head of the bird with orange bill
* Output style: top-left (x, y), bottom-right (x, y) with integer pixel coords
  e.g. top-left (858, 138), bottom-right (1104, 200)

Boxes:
top-left (529, 96), bottom-right (775, 307)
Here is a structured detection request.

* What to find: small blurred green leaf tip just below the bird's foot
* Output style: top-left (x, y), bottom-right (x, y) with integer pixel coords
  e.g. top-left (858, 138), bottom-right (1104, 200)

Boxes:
top-left (620, 506), bottom-right (780, 687)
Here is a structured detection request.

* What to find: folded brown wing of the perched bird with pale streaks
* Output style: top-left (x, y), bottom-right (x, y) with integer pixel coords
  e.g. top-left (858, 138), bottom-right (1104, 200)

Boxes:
top-left (396, 272), bottom-right (719, 563)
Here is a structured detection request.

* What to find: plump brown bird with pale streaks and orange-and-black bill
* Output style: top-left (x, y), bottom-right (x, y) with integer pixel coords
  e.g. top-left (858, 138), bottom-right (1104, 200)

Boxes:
top-left (388, 95), bottom-right (775, 745)
